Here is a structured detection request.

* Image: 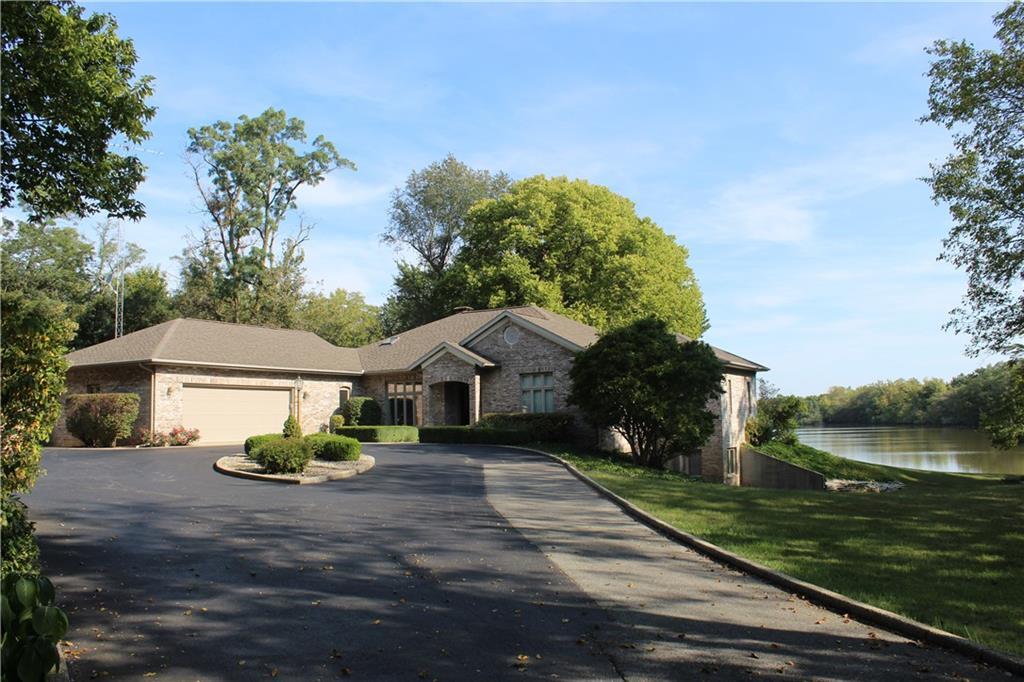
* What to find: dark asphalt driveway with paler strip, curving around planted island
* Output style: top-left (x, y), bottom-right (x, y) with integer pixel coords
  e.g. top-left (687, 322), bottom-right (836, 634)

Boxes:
top-left (27, 445), bottom-right (1006, 680)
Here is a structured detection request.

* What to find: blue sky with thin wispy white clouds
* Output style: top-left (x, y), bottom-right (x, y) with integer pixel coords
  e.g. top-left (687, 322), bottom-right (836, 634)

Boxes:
top-left (82, 3), bottom-right (1000, 394)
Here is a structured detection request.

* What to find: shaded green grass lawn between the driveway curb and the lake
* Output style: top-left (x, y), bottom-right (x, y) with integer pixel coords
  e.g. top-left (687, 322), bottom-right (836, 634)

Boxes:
top-left (544, 445), bottom-right (1024, 654)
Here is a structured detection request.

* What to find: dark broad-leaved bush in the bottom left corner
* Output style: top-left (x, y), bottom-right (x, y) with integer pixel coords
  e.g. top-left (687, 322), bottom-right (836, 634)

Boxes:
top-left (0, 573), bottom-right (68, 682)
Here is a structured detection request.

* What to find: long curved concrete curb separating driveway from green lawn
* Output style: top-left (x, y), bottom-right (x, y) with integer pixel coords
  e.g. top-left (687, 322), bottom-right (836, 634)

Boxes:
top-left (503, 445), bottom-right (1024, 676)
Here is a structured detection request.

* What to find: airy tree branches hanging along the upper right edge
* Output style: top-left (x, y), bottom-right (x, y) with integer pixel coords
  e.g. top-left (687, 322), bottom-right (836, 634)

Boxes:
top-left (922, 2), bottom-right (1024, 354)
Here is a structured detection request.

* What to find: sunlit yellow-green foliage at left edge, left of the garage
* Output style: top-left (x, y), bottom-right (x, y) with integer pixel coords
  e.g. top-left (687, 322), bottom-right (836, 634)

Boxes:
top-left (0, 285), bottom-right (75, 494)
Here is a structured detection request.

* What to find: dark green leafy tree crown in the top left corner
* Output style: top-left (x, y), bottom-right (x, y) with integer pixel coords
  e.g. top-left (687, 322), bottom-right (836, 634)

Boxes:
top-left (0, 0), bottom-right (156, 218)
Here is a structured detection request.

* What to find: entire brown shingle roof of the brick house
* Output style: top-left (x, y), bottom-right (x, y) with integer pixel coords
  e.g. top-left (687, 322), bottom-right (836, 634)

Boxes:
top-left (68, 305), bottom-right (767, 374)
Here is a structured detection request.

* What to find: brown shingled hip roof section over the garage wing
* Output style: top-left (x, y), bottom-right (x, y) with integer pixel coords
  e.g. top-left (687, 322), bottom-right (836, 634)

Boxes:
top-left (68, 317), bottom-right (362, 374)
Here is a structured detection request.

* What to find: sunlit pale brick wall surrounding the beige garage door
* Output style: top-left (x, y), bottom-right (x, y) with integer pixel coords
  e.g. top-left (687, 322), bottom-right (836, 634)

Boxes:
top-left (149, 366), bottom-right (359, 433)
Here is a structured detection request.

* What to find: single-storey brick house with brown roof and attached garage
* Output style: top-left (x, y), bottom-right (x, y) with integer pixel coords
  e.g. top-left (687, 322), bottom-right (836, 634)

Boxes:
top-left (53, 306), bottom-right (767, 479)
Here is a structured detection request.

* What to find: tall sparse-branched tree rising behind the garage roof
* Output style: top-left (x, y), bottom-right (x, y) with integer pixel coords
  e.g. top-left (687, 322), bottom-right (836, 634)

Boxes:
top-left (178, 109), bottom-right (355, 327)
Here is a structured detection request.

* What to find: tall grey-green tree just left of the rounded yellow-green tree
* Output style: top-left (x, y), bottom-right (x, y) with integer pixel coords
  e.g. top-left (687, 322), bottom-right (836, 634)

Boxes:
top-left (381, 154), bottom-right (512, 334)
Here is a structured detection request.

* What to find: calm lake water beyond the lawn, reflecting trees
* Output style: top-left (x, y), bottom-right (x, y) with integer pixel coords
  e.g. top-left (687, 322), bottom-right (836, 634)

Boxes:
top-left (797, 426), bottom-right (1024, 474)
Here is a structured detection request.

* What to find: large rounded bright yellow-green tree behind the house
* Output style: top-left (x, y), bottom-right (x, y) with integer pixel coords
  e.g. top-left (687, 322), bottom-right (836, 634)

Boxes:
top-left (445, 175), bottom-right (708, 338)
